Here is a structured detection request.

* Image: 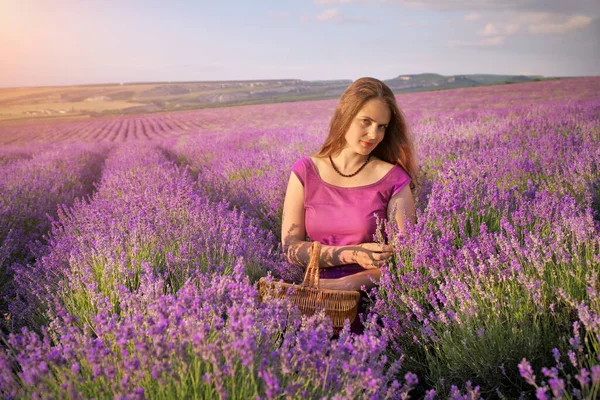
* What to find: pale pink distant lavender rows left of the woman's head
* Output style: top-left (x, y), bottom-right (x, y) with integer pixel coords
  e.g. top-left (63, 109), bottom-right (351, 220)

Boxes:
top-left (0, 97), bottom-right (334, 146)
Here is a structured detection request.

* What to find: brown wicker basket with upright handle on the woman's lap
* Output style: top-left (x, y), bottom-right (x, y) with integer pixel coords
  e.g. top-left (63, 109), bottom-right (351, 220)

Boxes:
top-left (259, 242), bottom-right (360, 331)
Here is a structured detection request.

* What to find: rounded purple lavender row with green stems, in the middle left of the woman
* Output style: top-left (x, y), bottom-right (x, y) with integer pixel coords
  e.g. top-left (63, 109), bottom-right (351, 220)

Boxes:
top-left (13, 146), bottom-right (279, 332)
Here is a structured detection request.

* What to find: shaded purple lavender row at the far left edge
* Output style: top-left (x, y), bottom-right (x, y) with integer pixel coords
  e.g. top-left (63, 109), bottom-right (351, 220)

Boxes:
top-left (0, 145), bottom-right (107, 328)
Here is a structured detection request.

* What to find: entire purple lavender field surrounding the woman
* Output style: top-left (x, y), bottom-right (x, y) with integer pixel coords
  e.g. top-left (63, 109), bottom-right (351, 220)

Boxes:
top-left (0, 78), bottom-right (600, 399)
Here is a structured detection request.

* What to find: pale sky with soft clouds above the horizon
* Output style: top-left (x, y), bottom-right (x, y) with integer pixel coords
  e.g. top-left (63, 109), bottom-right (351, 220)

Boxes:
top-left (0, 0), bottom-right (600, 87)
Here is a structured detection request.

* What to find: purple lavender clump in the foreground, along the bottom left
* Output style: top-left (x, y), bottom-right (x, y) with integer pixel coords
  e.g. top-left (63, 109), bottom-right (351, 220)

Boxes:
top-left (0, 265), bottom-right (417, 399)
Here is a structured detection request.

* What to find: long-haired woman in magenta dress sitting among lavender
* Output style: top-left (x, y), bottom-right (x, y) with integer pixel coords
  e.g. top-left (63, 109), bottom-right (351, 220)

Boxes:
top-left (281, 78), bottom-right (416, 332)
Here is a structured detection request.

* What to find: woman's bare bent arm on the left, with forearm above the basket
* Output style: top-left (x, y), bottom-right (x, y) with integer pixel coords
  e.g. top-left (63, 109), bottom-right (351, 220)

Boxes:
top-left (281, 172), bottom-right (392, 268)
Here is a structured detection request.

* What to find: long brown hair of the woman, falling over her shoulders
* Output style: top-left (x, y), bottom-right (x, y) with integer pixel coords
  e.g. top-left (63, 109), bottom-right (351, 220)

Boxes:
top-left (315, 78), bottom-right (417, 189)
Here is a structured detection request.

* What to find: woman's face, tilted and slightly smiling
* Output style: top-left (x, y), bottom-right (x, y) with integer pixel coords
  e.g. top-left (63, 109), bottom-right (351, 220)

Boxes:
top-left (345, 98), bottom-right (392, 155)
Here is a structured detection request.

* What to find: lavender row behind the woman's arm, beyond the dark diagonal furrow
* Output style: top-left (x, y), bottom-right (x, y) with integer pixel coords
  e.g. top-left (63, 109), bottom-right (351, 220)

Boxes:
top-left (172, 128), bottom-right (320, 236)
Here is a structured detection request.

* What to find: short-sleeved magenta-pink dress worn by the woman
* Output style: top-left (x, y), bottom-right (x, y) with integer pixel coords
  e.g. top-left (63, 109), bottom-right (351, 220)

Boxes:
top-left (292, 157), bottom-right (410, 279)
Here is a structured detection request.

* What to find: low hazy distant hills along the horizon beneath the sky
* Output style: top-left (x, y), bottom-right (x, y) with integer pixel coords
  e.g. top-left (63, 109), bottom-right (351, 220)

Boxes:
top-left (0, 73), bottom-right (550, 122)
